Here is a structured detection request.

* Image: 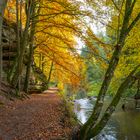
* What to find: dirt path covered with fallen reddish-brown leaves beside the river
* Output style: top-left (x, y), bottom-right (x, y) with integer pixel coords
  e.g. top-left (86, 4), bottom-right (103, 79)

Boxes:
top-left (0, 89), bottom-right (71, 140)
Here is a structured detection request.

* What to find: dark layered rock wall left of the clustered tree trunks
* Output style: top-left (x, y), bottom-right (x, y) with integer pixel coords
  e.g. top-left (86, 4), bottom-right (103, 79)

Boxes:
top-left (2, 19), bottom-right (17, 72)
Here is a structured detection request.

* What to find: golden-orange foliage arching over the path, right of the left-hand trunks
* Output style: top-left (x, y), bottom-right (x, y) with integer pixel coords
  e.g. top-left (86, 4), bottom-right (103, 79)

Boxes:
top-left (34, 0), bottom-right (84, 91)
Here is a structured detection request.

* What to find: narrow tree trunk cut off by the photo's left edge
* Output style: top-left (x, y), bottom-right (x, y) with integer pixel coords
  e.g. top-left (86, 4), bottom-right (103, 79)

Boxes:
top-left (0, 0), bottom-right (7, 92)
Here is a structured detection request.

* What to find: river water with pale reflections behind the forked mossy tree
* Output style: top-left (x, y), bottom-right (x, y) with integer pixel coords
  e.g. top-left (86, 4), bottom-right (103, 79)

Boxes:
top-left (74, 98), bottom-right (140, 140)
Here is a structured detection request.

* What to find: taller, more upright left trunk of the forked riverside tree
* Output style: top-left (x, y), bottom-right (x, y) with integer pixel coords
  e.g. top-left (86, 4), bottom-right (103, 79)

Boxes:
top-left (80, 0), bottom-right (139, 140)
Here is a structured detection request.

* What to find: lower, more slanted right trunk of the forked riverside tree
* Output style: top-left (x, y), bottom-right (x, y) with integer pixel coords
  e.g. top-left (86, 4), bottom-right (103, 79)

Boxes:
top-left (84, 66), bottom-right (140, 140)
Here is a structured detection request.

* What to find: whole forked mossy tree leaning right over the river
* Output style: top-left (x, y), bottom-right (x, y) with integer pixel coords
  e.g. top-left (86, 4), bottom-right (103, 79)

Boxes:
top-left (79, 0), bottom-right (140, 140)
